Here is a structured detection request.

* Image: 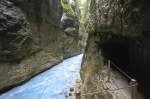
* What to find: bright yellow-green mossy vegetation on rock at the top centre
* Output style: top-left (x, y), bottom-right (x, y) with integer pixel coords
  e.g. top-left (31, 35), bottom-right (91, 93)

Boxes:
top-left (61, 0), bottom-right (75, 17)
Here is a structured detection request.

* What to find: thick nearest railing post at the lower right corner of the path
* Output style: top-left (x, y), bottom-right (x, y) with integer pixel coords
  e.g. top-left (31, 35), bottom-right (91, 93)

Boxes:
top-left (131, 79), bottom-right (138, 99)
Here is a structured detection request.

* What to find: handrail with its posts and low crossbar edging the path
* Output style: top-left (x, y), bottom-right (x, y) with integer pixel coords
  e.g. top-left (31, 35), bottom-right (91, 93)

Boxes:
top-left (80, 60), bottom-right (138, 99)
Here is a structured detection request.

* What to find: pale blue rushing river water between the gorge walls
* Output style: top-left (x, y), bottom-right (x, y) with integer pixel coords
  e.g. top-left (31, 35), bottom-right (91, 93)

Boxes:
top-left (0, 54), bottom-right (83, 99)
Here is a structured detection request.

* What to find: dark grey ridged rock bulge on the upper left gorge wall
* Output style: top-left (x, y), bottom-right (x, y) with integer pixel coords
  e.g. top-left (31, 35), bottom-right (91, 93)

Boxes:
top-left (0, 0), bottom-right (32, 61)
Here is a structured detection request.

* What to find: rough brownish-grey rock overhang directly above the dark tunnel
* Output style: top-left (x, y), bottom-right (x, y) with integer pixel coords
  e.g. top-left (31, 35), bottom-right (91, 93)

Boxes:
top-left (88, 0), bottom-right (150, 36)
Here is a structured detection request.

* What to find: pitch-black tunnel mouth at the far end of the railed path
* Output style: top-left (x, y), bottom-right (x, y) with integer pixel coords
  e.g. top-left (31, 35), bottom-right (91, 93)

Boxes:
top-left (99, 36), bottom-right (130, 73)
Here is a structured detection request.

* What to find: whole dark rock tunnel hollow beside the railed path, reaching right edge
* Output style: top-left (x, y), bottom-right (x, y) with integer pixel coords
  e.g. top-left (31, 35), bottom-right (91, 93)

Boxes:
top-left (98, 35), bottom-right (150, 98)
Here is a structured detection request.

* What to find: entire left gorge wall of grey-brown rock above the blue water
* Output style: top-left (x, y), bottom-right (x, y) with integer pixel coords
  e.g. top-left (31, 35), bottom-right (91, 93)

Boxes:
top-left (0, 0), bottom-right (81, 89)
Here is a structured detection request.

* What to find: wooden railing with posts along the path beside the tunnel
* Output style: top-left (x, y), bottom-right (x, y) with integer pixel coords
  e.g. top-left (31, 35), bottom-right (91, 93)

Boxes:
top-left (80, 60), bottom-right (139, 99)
